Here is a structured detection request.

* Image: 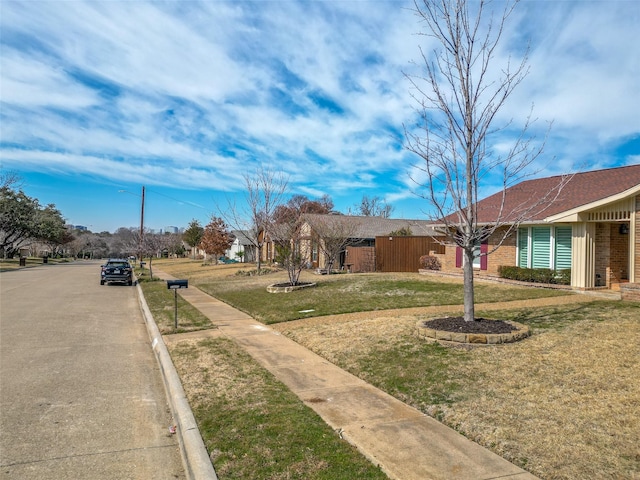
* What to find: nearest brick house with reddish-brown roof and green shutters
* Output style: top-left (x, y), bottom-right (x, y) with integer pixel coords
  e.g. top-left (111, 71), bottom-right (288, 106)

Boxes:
top-left (439, 165), bottom-right (640, 289)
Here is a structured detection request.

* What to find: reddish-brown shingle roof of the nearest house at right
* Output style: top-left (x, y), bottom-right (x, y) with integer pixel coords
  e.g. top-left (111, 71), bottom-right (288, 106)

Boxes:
top-left (470, 165), bottom-right (640, 223)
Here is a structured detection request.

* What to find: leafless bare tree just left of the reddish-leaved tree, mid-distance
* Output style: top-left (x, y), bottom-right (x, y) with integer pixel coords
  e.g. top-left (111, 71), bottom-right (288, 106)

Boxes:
top-left (218, 167), bottom-right (288, 273)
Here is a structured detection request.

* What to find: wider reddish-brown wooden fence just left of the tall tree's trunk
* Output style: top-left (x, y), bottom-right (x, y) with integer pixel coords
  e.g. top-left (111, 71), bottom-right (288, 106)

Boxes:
top-left (375, 236), bottom-right (444, 272)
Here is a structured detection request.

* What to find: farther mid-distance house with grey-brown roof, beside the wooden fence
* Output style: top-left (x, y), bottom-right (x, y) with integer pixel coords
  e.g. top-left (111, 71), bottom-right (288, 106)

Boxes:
top-left (300, 213), bottom-right (435, 272)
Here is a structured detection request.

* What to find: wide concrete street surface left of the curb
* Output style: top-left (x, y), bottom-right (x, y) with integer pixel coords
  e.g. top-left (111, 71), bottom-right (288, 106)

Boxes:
top-left (0, 261), bottom-right (185, 480)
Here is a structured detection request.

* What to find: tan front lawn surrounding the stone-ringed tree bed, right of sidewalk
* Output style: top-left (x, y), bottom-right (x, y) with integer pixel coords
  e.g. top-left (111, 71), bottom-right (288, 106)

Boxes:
top-left (156, 264), bottom-right (640, 480)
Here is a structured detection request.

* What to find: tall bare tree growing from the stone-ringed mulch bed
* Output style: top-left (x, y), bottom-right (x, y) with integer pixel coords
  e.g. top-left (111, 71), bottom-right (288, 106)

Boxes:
top-left (405, 0), bottom-right (563, 321)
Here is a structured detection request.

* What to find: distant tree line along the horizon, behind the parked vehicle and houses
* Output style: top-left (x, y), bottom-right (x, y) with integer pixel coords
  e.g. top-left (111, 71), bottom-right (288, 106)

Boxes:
top-left (0, 170), bottom-right (393, 268)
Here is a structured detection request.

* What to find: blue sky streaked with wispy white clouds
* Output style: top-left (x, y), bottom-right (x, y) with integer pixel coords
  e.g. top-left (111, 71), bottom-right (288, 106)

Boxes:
top-left (0, 0), bottom-right (640, 232)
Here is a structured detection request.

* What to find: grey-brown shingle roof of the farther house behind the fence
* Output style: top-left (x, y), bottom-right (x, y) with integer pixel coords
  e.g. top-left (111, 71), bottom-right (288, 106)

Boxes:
top-left (303, 213), bottom-right (434, 239)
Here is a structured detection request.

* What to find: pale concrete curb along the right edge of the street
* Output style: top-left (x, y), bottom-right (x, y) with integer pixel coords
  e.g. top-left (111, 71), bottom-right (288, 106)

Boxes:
top-left (136, 284), bottom-right (218, 480)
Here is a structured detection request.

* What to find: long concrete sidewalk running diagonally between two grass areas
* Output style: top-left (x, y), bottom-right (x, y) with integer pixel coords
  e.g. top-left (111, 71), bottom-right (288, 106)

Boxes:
top-left (156, 270), bottom-right (537, 480)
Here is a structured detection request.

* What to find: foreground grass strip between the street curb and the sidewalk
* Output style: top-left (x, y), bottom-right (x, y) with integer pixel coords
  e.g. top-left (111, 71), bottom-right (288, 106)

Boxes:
top-left (170, 338), bottom-right (387, 480)
